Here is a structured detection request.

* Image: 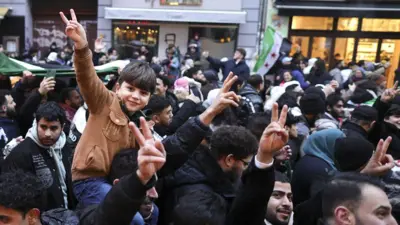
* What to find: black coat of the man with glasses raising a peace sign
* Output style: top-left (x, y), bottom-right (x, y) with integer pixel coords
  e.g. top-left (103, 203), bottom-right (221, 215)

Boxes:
top-left (159, 149), bottom-right (274, 225)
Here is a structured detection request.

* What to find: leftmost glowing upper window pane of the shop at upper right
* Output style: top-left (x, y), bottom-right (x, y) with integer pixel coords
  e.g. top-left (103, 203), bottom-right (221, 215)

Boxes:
top-left (292, 16), bottom-right (333, 30)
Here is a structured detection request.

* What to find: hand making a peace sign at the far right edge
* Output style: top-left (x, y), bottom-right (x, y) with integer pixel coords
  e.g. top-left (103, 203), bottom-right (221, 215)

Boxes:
top-left (361, 137), bottom-right (395, 176)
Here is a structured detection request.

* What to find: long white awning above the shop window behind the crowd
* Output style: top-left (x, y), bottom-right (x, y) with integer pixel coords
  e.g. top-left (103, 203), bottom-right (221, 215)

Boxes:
top-left (105, 7), bottom-right (246, 24)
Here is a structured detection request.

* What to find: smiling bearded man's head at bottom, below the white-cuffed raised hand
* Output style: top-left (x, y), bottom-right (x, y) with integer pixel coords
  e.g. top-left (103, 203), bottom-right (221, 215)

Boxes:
top-left (265, 171), bottom-right (293, 225)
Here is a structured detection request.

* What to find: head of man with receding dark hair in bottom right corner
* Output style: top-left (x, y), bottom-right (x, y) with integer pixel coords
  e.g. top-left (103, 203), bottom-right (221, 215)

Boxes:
top-left (322, 174), bottom-right (397, 225)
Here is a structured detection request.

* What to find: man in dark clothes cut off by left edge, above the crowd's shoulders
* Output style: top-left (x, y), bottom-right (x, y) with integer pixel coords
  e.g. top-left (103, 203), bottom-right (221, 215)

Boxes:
top-left (0, 90), bottom-right (20, 149)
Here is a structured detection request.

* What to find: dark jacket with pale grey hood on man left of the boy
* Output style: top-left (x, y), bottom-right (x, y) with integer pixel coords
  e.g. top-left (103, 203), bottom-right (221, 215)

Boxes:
top-left (2, 121), bottom-right (76, 210)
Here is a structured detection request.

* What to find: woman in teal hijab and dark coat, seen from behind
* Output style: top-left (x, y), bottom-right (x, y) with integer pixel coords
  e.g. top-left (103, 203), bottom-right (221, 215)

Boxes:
top-left (291, 129), bottom-right (345, 207)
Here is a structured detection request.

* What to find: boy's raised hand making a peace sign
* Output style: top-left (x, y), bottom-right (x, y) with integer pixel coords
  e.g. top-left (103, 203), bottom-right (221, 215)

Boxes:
top-left (60, 9), bottom-right (87, 49)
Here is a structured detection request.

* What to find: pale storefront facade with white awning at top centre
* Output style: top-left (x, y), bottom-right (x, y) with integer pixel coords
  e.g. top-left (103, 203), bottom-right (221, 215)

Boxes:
top-left (98, 0), bottom-right (260, 58)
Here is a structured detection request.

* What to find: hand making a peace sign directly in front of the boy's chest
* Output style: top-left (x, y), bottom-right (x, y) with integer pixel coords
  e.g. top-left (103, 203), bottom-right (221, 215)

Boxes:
top-left (129, 117), bottom-right (167, 184)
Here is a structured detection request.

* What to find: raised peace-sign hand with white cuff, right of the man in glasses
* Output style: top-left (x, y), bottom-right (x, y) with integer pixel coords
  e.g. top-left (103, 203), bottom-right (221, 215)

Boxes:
top-left (257, 103), bottom-right (289, 164)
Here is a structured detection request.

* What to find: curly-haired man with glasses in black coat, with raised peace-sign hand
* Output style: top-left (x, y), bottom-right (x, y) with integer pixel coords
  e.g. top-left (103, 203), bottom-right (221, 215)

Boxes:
top-left (159, 104), bottom-right (288, 225)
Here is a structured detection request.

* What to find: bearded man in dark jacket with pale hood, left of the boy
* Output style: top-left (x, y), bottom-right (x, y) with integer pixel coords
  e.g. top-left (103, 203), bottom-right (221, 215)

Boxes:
top-left (2, 102), bottom-right (75, 210)
